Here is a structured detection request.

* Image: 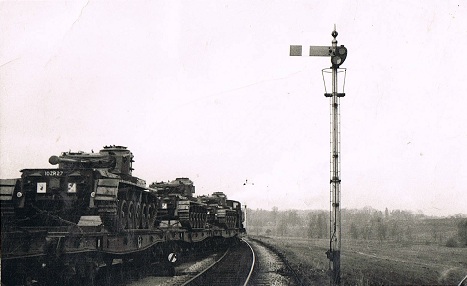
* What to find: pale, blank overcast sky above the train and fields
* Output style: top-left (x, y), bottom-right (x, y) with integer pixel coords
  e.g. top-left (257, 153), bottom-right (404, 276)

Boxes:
top-left (0, 0), bottom-right (467, 215)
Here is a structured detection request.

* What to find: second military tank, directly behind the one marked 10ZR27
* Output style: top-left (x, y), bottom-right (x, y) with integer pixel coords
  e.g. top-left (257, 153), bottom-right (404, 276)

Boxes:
top-left (149, 178), bottom-right (207, 229)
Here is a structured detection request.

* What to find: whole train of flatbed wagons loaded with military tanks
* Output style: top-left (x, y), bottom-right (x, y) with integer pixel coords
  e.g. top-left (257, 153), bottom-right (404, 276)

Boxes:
top-left (0, 145), bottom-right (245, 285)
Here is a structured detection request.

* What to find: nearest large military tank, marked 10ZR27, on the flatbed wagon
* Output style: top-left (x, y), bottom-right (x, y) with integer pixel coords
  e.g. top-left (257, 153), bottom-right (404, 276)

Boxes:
top-left (0, 145), bottom-right (157, 231)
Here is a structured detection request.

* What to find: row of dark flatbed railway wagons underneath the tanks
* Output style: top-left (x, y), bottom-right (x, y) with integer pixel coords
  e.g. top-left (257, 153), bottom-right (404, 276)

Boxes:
top-left (2, 216), bottom-right (245, 285)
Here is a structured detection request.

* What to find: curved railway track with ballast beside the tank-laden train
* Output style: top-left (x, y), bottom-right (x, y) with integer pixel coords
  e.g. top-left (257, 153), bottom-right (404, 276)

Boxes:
top-left (117, 236), bottom-right (302, 286)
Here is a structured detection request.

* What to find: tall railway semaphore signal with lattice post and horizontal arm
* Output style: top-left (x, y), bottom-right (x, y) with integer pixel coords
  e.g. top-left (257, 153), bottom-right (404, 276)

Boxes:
top-left (290, 25), bottom-right (347, 285)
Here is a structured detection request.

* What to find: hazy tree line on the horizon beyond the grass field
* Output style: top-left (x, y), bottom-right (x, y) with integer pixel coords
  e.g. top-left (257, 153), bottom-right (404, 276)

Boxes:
top-left (246, 207), bottom-right (467, 246)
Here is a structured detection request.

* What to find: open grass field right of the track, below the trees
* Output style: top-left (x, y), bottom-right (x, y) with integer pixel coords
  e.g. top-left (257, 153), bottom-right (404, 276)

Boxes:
top-left (253, 237), bottom-right (467, 285)
